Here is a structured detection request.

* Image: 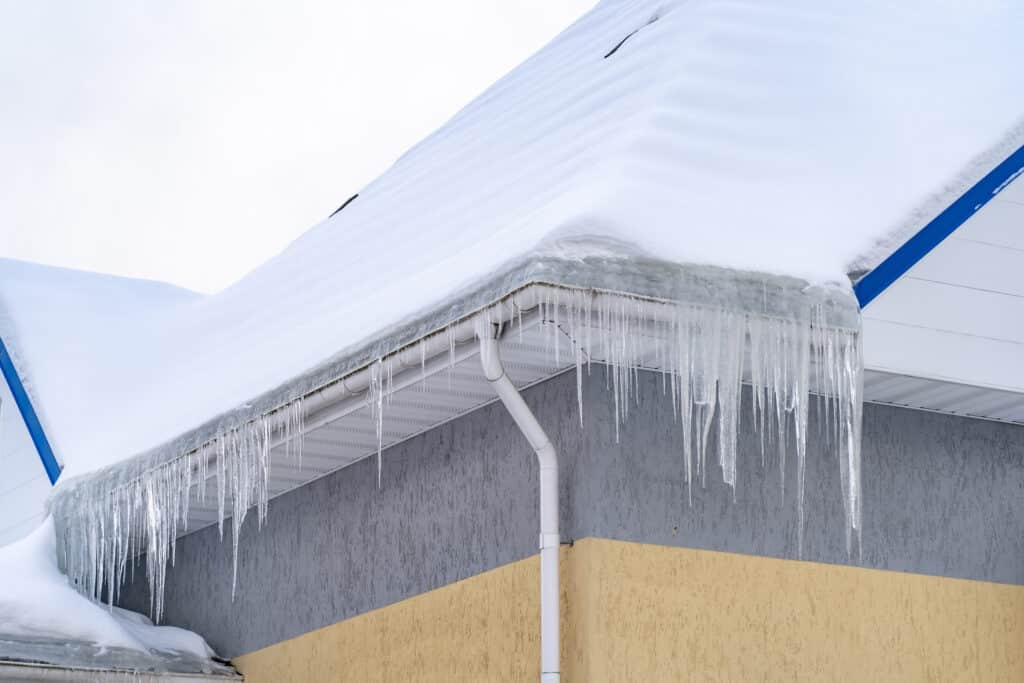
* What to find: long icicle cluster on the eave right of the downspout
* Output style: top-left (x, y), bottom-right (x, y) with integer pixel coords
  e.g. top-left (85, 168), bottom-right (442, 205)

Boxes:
top-left (539, 285), bottom-right (862, 555)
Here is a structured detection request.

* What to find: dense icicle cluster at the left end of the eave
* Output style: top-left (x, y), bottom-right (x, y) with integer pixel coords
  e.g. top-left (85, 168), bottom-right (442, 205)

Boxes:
top-left (53, 401), bottom-right (303, 621)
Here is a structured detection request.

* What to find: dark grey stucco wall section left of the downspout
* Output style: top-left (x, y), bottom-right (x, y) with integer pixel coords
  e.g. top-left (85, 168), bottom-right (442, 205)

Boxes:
top-left (122, 378), bottom-right (582, 657)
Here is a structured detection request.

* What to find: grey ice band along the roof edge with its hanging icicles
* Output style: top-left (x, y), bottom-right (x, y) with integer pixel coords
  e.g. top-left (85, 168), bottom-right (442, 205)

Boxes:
top-left (50, 243), bottom-right (862, 618)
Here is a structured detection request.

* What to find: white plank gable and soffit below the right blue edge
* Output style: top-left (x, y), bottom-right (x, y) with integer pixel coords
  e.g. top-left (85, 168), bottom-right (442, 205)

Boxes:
top-left (864, 176), bottom-right (1024, 423)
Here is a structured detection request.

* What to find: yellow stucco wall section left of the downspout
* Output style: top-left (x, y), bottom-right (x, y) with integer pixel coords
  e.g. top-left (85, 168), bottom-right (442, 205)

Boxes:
top-left (234, 550), bottom-right (552, 683)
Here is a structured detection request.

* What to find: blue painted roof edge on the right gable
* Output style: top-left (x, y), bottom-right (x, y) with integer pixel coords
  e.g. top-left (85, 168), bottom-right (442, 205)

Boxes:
top-left (853, 146), bottom-right (1024, 308)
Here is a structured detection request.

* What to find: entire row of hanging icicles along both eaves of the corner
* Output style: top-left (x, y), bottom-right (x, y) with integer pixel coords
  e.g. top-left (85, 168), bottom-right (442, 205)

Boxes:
top-left (53, 288), bottom-right (862, 621)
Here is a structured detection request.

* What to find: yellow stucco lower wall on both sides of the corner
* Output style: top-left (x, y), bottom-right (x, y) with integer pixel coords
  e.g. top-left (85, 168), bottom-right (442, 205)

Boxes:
top-left (236, 539), bottom-right (1024, 683)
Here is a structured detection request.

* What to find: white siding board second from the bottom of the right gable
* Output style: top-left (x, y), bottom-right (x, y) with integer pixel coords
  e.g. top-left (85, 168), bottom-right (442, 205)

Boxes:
top-left (864, 278), bottom-right (1024, 344)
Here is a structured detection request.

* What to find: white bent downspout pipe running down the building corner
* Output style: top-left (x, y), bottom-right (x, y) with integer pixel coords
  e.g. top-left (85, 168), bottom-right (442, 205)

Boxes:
top-left (478, 325), bottom-right (561, 683)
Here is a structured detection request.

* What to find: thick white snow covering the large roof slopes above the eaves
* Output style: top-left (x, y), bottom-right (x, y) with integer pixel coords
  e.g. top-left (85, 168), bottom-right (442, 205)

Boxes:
top-left (8, 0), bottom-right (1024, 485)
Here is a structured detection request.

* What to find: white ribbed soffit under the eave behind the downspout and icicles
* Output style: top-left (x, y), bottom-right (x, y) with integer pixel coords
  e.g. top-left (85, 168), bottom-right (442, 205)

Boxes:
top-left (178, 286), bottom-right (860, 536)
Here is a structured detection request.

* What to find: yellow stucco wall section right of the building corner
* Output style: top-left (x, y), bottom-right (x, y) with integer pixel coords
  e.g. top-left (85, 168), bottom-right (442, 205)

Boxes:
top-left (566, 539), bottom-right (1024, 683)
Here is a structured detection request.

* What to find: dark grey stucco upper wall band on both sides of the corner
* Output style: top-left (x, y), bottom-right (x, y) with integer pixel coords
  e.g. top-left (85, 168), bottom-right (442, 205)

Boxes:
top-left (123, 370), bottom-right (1024, 657)
